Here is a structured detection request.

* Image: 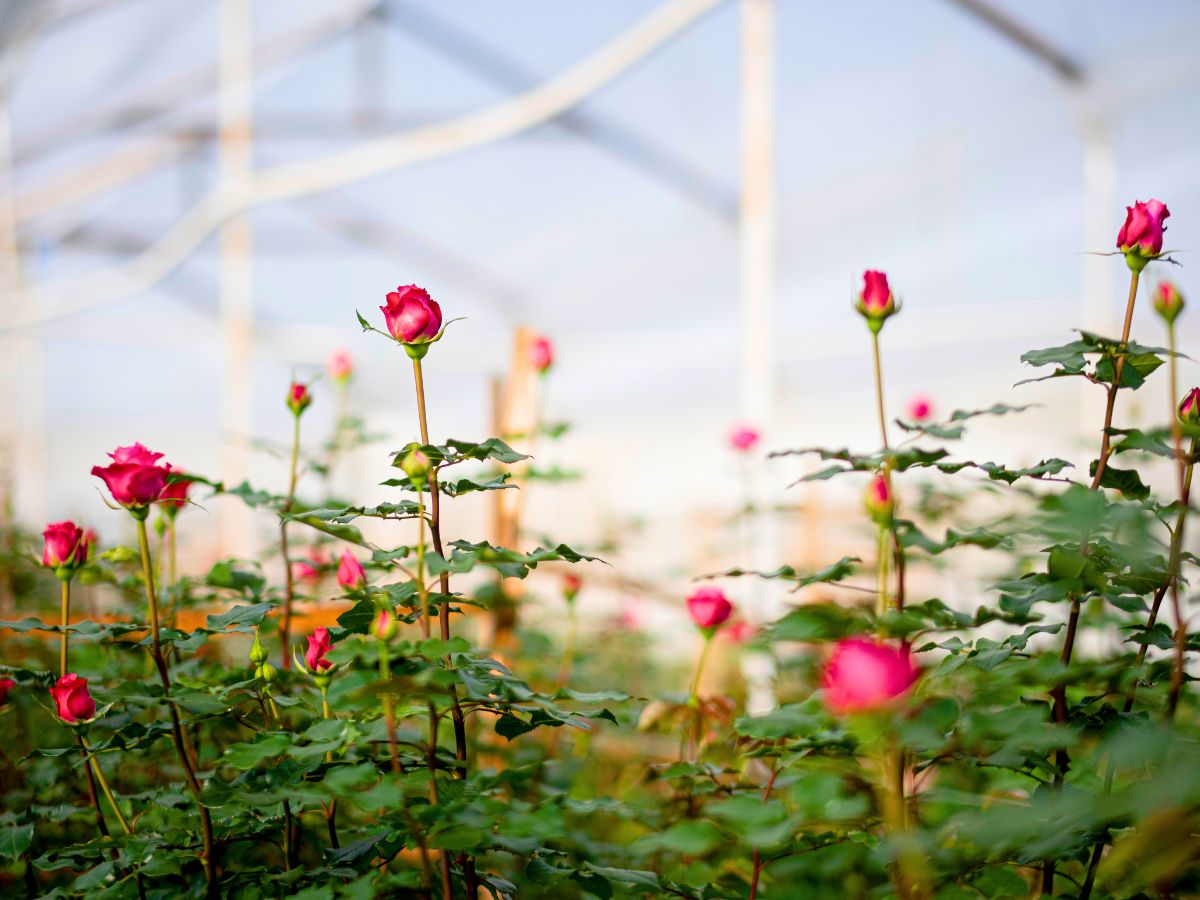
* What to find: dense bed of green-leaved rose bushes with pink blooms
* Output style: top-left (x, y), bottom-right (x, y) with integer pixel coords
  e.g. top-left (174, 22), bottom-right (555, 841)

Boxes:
top-left (0, 202), bottom-right (1200, 899)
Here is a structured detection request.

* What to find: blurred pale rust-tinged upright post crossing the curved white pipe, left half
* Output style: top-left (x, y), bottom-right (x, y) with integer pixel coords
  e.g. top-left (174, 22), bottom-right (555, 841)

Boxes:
top-left (217, 0), bottom-right (254, 556)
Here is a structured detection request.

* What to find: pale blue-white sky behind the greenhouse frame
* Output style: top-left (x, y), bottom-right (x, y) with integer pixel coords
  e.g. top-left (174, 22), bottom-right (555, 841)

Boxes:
top-left (12, 0), bottom-right (1200, 592)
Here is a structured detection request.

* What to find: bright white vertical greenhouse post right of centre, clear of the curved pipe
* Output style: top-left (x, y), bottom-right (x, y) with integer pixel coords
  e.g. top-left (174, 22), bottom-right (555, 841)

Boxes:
top-left (738, 0), bottom-right (779, 714)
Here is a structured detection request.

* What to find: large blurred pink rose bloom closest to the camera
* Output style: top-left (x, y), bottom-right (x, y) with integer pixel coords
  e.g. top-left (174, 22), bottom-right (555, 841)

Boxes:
top-left (821, 637), bottom-right (920, 715)
